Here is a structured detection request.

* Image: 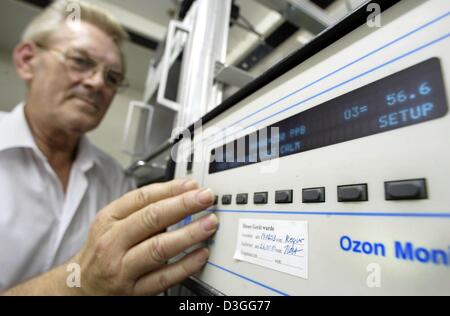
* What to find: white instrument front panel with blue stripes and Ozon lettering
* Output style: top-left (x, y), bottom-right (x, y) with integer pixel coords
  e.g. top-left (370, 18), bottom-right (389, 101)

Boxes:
top-left (176, 0), bottom-right (450, 296)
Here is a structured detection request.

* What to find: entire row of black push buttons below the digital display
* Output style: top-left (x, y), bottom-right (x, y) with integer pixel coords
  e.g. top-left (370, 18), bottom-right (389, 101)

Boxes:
top-left (215, 179), bottom-right (428, 205)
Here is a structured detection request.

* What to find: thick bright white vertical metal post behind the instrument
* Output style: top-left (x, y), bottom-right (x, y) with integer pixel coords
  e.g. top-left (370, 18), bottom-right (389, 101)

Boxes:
top-left (177, 0), bottom-right (231, 127)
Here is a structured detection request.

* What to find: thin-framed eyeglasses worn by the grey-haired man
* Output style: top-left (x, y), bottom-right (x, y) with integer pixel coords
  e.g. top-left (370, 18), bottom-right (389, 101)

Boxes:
top-left (36, 43), bottom-right (128, 90)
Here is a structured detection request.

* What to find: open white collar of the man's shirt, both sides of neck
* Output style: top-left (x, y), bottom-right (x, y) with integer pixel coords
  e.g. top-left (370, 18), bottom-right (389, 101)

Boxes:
top-left (0, 103), bottom-right (101, 172)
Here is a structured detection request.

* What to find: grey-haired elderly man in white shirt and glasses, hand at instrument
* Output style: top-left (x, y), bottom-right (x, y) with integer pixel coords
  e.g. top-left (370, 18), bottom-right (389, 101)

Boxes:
top-left (0, 1), bottom-right (217, 295)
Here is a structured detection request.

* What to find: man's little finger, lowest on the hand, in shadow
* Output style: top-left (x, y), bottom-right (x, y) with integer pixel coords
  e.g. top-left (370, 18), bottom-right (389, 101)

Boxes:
top-left (134, 249), bottom-right (209, 295)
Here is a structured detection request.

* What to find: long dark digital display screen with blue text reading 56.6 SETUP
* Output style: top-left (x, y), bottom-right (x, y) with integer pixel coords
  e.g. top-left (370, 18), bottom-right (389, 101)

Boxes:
top-left (209, 58), bottom-right (448, 174)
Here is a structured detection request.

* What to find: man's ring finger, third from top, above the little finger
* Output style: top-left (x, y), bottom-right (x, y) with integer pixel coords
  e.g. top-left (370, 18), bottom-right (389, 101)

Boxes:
top-left (123, 214), bottom-right (218, 279)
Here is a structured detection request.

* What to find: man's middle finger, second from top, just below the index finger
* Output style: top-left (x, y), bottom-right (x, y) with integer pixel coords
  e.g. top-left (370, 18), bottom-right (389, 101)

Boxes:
top-left (118, 189), bottom-right (214, 248)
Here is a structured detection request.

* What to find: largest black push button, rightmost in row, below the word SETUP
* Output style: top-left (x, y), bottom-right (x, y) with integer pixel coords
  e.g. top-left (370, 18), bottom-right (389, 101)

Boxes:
top-left (384, 179), bottom-right (428, 201)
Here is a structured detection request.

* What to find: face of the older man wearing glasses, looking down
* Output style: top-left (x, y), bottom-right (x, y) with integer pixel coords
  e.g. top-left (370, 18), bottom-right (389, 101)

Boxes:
top-left (28, 23), bottom-right (123, 134)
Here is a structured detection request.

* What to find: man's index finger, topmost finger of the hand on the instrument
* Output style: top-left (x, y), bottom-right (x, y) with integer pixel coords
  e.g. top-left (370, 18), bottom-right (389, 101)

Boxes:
top-left (108, 179), bottom-right (198, 220)
